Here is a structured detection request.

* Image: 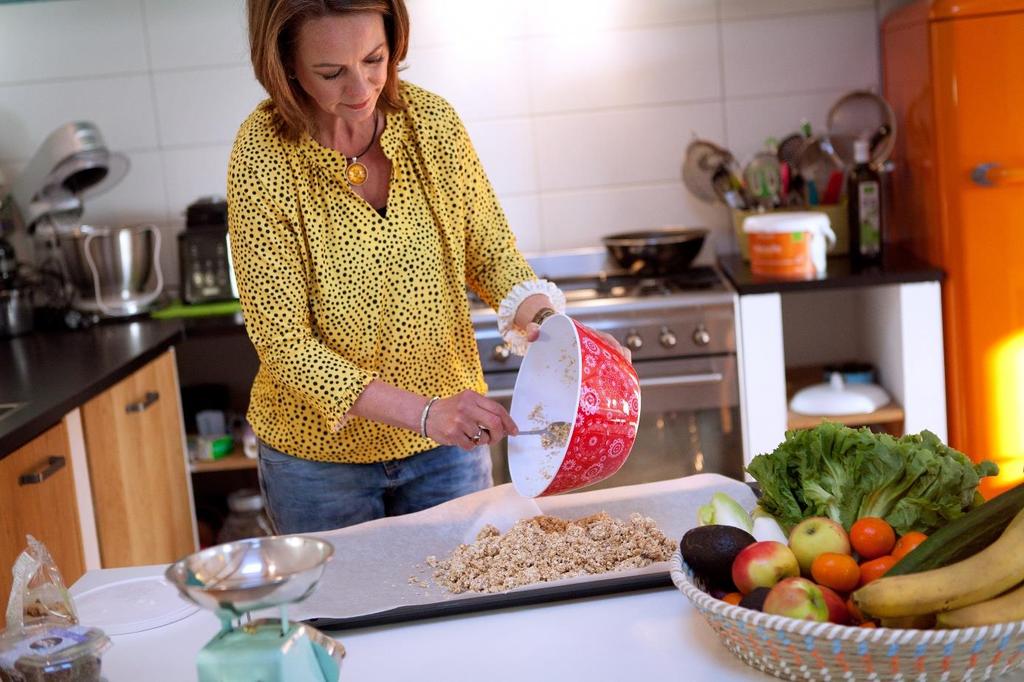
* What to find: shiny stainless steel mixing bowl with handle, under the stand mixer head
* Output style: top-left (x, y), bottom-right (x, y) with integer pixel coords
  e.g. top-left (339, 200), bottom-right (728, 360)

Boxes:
top-left (58, 225), bottom-right (164, 316)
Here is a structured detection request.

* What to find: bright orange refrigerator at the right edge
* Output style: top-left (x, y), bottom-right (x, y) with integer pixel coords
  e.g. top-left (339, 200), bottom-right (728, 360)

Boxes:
top-left (882, 0), bottom-right (1024, 496)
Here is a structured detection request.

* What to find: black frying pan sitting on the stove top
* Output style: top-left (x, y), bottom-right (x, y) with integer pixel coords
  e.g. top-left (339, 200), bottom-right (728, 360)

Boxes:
top-left (602, 227), bottom-right (708, 278)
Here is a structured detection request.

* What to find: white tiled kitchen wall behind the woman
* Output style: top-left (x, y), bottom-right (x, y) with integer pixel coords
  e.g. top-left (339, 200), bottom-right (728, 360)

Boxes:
top-left (0, 0), bottom-right (884, 282)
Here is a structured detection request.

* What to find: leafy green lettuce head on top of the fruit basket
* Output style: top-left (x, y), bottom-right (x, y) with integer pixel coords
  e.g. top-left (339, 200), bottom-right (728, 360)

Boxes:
top-left (746, 422), bottom-right (998, 535)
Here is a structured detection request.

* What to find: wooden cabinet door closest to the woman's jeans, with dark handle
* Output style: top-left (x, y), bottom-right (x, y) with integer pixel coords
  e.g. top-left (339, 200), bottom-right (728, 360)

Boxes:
top-left (82, 350), bottom-right (196, 568)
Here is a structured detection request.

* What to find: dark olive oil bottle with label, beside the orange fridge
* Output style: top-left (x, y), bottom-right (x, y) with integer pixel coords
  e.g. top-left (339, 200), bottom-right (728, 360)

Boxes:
top-left (846, 139), bottom-right (883, 264)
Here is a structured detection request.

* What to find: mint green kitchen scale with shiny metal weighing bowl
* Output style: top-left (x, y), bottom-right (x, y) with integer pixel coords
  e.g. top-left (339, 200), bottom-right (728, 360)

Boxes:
top-left (166, 536), bottom-right (345, 682)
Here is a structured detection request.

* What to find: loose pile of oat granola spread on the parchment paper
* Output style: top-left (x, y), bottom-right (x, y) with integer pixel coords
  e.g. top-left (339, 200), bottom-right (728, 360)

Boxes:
top-left (426, 512), bottom-right (675, 594)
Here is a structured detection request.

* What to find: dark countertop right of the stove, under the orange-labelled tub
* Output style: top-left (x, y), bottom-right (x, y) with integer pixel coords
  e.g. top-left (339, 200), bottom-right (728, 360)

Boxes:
top-left (718, 248), bottom-right (945, 296)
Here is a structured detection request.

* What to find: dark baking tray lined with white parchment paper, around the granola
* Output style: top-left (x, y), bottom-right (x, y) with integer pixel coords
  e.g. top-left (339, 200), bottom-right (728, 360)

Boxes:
top-left (291, 474), bottom-right (755, 630)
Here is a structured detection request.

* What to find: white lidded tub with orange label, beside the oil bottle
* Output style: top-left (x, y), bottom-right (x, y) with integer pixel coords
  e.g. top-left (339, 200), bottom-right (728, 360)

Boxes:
top-left (743, 211), bottom-right (836, 280)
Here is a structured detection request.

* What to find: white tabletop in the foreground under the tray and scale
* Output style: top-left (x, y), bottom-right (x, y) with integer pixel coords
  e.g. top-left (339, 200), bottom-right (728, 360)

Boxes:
top-left (71, 566), bottom-right (774, 682)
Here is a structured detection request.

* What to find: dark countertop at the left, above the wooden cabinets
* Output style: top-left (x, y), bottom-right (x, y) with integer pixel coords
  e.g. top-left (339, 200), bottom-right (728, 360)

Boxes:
top-left (0, 319), bottom-right (183, 459)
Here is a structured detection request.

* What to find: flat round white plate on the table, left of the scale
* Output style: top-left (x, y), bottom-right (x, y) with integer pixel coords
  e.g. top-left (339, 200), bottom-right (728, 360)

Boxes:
top-left (75, 576), bottom-right (199, 635)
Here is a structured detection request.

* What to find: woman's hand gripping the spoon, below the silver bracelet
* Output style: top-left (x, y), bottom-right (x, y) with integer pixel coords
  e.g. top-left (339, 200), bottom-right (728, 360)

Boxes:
top-left (426, 390), bottom-right (519, 450)
